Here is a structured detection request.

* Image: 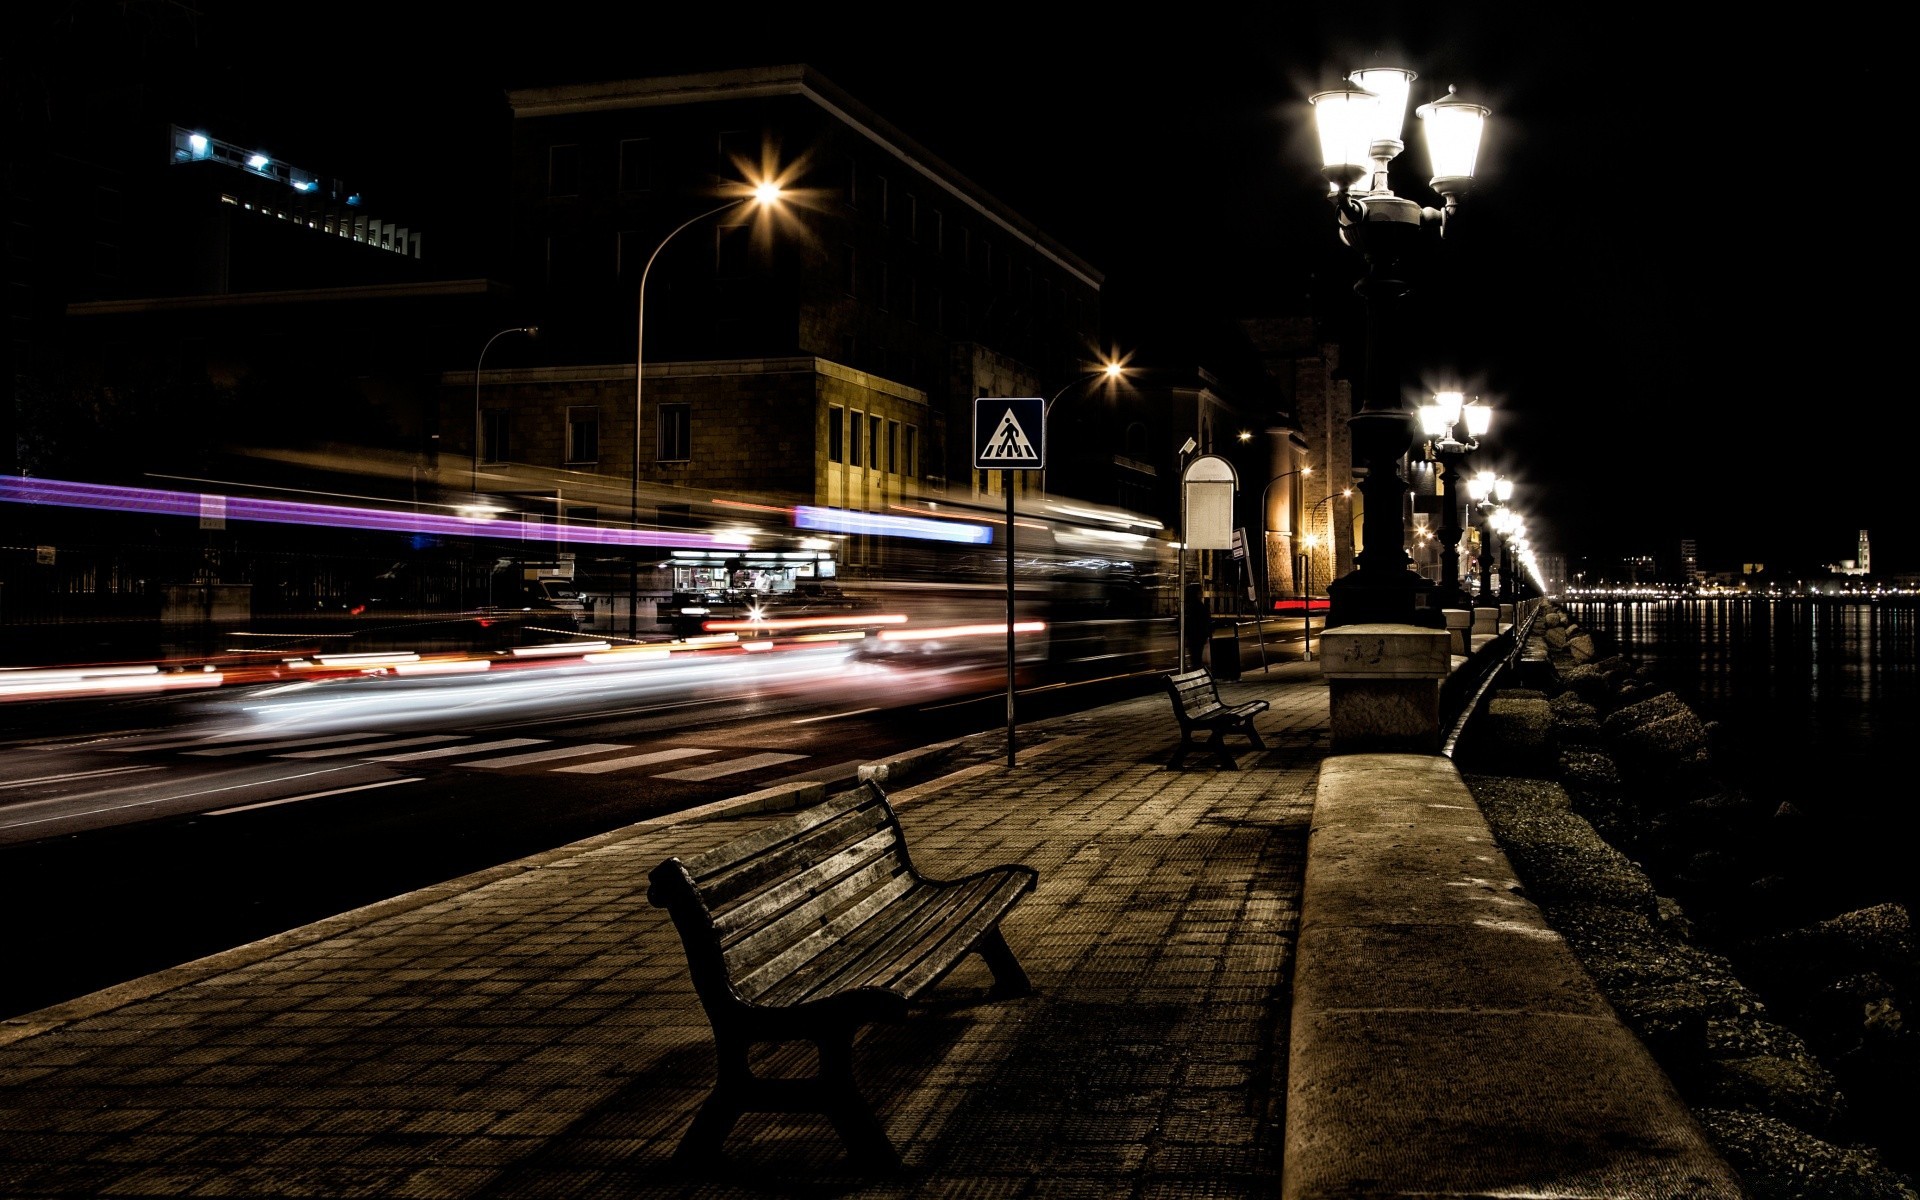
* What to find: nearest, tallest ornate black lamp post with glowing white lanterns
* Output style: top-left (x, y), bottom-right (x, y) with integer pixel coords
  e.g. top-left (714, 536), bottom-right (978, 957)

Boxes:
top-left (1311, 67), bottom-right (1488, 626)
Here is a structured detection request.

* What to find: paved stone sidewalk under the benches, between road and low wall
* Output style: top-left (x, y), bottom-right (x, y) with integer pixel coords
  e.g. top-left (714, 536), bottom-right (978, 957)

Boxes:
top-left (0, 662), bottom-right (1327, 1200)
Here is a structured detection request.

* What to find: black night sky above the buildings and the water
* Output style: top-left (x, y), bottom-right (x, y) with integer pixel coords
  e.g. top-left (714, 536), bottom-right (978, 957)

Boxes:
top-left (22, 0), bottom-right (1920, 570)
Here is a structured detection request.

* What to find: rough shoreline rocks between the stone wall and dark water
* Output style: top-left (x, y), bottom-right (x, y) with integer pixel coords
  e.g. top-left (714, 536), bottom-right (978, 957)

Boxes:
top-left (1453, 601), bottom-right (1920, 1200)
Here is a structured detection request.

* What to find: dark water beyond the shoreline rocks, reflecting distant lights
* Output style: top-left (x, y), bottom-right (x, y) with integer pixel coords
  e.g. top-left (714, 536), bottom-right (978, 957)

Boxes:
top-left (1567, 597), bottom-right (1920, 916)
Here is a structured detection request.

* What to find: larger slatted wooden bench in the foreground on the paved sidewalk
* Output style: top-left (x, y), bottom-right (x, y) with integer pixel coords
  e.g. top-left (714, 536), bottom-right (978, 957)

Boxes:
top-left (647, 781), bottom-right (1039, 1169)
